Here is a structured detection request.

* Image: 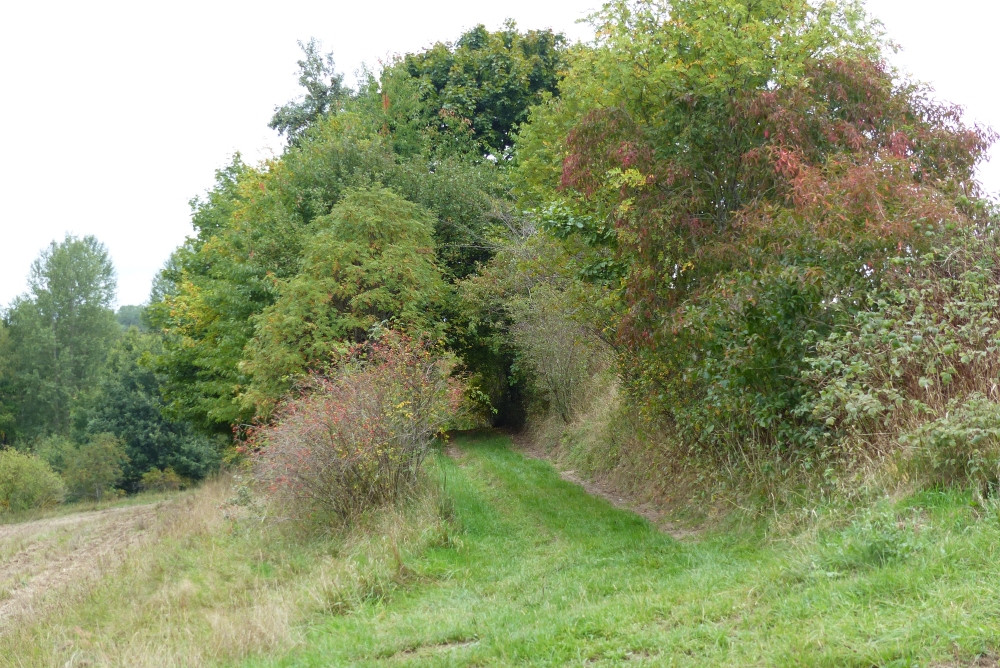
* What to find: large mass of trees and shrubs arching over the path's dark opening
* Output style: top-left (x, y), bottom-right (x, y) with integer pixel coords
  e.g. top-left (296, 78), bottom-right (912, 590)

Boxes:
top-left (7, 0), bottom-right (1000, 516)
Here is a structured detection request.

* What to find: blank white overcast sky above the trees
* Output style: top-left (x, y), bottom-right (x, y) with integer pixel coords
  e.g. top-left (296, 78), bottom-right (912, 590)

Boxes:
top-left (0, 0), bottom-right (1000, 307)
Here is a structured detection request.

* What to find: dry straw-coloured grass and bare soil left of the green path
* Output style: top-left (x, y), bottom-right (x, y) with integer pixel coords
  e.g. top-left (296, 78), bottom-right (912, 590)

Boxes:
top-left (0, 480), bottom-right (448, 668)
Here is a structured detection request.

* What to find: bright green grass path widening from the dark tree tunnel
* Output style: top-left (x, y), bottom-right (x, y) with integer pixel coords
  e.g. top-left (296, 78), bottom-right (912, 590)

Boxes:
top-left (245, 436), bottom-right (1000, 666)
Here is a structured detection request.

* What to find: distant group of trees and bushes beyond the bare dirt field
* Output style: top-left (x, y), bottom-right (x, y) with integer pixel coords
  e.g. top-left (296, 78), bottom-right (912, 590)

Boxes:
top-left (0, 236), bottom-right (221, 510)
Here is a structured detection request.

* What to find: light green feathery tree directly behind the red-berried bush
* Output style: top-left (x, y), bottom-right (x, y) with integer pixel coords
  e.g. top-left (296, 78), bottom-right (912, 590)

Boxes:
top-left (243, 188), bottom-right (446, 412)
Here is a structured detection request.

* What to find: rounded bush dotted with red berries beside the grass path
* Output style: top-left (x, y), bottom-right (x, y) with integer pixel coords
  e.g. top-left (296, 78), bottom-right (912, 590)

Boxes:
top-left (245, 333), bottom-right (463, 524)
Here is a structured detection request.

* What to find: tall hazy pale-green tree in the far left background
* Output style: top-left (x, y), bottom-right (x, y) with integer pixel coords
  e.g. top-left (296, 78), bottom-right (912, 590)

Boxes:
top-left (6, 236), bottom-right (120, 437)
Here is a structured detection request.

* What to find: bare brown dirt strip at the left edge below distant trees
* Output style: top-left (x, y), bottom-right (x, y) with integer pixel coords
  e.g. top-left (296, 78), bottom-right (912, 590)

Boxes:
top-left (0, 504), bottom-right (161, 633)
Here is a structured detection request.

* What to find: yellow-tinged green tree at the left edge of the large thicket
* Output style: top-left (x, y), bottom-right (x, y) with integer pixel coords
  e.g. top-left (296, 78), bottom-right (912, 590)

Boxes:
top-left (146, 155), bottom-right (264, 432)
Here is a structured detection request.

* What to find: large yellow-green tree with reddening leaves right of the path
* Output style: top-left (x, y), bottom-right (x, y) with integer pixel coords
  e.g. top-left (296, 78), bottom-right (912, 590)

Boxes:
top-left (518, 0), bottom-right (992, 448)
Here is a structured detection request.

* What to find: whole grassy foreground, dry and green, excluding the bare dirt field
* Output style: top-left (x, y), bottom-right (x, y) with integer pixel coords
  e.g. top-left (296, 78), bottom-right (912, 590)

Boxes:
top-left (0, 435), bottom-right (1000, 667)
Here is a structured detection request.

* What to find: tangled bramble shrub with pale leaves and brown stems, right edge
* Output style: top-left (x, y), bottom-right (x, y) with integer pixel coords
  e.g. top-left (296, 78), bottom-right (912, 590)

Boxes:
top-left (802, 231), bottom-right (1000, 454)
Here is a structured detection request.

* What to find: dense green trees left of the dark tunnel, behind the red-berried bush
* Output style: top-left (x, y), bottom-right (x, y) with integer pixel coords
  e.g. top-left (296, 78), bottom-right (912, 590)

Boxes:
top-left (151, 25), bottom-right (563, 431)
